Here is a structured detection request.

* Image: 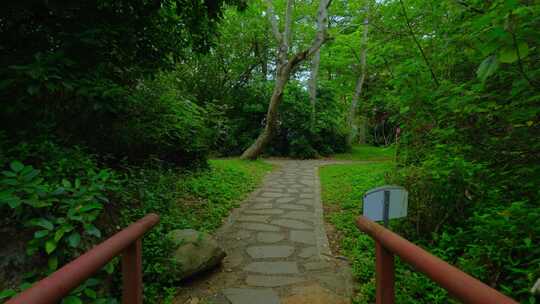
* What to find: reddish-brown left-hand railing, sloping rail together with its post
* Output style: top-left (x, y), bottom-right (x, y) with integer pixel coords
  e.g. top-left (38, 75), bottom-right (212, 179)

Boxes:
top-left (6, 213), bottom-right (159, 304)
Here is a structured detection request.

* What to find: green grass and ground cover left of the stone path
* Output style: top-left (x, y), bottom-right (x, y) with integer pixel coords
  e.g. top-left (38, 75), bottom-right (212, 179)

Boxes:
top-left (122, 159), bottom-right (273, 303)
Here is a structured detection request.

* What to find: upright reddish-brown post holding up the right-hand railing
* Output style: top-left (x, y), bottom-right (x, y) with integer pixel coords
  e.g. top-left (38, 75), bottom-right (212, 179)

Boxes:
top-left (375, 241), bottom-right (394, 304)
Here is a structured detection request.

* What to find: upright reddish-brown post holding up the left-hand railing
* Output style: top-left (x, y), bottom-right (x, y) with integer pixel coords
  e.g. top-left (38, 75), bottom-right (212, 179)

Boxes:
top-left (122, 238), bottom-right (142, 304)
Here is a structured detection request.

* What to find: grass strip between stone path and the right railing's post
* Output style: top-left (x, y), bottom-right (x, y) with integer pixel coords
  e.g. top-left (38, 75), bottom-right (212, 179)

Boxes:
top-left (319, 146), bottom-right (394, 303)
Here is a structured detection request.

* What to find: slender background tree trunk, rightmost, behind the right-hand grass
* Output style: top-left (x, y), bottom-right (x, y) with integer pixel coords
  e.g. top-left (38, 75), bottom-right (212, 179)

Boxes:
top-left (347, 13), bottom-right (369, 145)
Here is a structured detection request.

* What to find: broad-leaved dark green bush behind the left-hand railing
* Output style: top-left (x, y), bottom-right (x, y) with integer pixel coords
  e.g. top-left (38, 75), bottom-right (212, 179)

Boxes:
top-left (0, 141), bottom-right (118, 303)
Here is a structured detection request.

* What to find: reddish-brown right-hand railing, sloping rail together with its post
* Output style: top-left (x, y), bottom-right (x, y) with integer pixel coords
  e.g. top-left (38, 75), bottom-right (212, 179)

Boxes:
top-left (356, 216), bottom-right (517, 304)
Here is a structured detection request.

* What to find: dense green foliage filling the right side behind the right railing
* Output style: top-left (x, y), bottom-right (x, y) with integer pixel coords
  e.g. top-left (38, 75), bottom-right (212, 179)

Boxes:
top-left (354, 1), bottom-right (540, 303)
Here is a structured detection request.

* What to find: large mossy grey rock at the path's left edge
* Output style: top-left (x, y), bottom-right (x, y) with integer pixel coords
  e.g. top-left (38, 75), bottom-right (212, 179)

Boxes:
top-left (167, 229), bottom-right (226, 280)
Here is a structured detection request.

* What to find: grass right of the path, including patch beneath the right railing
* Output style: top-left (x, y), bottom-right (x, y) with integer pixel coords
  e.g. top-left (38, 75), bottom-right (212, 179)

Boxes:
top-left (319, 146), bottom-right (446, 304)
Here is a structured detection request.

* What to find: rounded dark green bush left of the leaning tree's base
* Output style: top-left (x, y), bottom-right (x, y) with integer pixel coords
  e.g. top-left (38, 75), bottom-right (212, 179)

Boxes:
top-left (110, 73), bottom-right (210, 166)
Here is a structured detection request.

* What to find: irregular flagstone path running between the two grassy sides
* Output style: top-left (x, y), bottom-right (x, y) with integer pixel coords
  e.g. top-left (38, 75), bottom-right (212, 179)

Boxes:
top-left (176, 160), bottom-right (352, 304)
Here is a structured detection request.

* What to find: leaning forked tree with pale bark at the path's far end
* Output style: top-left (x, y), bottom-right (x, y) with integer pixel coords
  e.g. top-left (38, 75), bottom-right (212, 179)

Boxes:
top-left (241, 0), bottom-right (331, 159)
